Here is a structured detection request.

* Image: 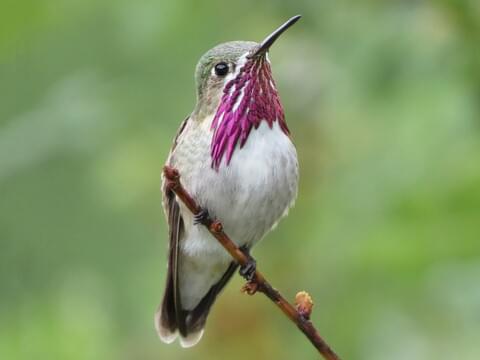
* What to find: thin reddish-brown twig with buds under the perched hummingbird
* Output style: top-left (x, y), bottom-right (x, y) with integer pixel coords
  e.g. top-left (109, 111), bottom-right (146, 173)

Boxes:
top-left (163, 166), bottom-right (340, 360)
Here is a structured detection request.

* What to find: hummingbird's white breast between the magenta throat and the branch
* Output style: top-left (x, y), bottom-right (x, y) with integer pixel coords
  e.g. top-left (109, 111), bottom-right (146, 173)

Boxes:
top-left (172, 122), bottom-right (298, 245)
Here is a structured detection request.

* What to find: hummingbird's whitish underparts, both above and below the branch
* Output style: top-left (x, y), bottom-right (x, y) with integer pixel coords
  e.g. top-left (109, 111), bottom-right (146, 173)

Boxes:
top-left (169, 119), bottom-right (298, 309)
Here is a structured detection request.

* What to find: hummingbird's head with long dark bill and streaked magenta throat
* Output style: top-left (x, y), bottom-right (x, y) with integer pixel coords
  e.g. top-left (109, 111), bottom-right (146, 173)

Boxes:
top-left (194, 15), bottom-right (300, 169)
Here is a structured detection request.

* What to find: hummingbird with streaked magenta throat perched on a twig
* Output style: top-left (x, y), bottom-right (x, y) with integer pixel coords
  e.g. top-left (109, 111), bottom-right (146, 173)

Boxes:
top-left (155, 15), bottom-right (300, 347)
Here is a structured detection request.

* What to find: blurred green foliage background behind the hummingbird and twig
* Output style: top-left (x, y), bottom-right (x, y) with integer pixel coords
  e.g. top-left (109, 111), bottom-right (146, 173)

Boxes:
top-left (0, 0), bottom-right (480, 360)
